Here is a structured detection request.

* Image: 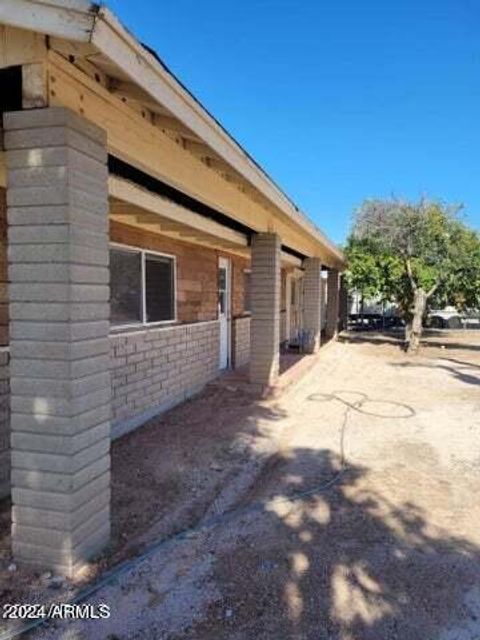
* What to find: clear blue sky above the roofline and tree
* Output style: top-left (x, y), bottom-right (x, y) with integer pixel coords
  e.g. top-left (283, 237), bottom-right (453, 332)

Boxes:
top-left (107, 0), bottom-right (480, 242)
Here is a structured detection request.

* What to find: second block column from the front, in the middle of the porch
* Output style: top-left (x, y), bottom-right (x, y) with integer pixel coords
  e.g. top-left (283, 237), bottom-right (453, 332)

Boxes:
top-left (250, 233), bottom-right (280, 387)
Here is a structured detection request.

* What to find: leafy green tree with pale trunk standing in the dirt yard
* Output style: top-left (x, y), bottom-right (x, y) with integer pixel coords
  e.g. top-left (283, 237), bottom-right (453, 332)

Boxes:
top-left (346, 199), bottom-right (480, 352)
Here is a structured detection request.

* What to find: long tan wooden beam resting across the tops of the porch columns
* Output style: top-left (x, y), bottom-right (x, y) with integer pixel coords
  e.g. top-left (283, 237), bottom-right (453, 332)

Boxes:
top-left (48, 51), bottom-right (337, 266)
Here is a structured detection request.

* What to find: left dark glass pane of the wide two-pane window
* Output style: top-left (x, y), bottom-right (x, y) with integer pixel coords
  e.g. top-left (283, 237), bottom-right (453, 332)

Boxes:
top-left (110, 249), bottom-right (142, 324)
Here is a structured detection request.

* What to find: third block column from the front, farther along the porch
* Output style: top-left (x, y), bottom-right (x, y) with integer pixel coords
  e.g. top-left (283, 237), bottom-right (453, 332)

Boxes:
top-left (303, 258), bottom-right (322, 353)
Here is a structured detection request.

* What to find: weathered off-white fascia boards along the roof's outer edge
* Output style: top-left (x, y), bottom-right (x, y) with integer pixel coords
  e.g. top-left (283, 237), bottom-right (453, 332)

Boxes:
top-left (0, 0), bottom-right (344, 266)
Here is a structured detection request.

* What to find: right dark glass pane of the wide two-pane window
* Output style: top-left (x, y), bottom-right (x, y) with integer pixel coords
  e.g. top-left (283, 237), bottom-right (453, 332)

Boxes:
top-left (145, 253), bottom-right (175, 322)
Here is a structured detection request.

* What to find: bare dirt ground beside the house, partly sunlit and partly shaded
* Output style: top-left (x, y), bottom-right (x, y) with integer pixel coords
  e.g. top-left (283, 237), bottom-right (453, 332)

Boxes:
top-left (0, 332), bottom-right (480, 640)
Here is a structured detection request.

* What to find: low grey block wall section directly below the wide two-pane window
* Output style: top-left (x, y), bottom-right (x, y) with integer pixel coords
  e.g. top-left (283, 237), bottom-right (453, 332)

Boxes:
top-left (110, 320), bottom-right (220, 438)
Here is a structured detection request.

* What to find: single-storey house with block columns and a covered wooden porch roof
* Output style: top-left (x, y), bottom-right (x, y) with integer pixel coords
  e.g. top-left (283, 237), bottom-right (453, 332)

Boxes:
top-left (0, 0), bottom-right (343, 575)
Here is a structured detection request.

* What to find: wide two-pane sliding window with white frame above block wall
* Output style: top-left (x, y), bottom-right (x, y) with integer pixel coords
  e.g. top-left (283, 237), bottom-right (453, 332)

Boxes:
top-left (110, 246), bottom-right (176, 325)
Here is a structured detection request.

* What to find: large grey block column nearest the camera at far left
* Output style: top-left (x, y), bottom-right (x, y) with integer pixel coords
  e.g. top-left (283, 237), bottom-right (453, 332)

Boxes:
top-left (4, 108), bottom-right (111, 575)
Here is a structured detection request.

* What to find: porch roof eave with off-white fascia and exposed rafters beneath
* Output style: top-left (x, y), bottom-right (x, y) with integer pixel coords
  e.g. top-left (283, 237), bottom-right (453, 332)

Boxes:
top-left (0, 0), bottom-right (344, 268)
